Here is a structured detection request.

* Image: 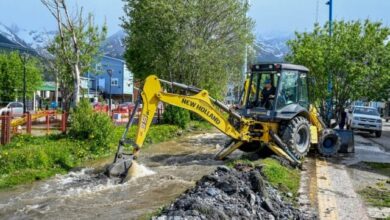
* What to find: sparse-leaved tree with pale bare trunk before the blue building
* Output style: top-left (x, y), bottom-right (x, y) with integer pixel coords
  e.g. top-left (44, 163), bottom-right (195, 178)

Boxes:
top-left (41, 0), bottom-right (107, 109)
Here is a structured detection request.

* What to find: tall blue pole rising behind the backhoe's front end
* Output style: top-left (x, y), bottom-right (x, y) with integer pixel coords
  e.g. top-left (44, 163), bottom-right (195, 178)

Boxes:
top-left (326, 0), bottom-right (333, 125)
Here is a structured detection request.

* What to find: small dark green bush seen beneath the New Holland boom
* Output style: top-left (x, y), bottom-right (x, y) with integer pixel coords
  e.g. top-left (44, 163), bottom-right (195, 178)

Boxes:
top-left (163, 105), bottom-right (191, 128)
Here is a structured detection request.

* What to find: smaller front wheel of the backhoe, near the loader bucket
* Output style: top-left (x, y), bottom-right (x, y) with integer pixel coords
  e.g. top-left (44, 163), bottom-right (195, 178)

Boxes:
top-left (317, 129), bottom-right (341, 157)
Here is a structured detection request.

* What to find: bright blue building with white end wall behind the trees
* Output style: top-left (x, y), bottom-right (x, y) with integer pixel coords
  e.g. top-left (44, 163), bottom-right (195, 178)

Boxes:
top-left (85, 56), bottom-right (134, 102)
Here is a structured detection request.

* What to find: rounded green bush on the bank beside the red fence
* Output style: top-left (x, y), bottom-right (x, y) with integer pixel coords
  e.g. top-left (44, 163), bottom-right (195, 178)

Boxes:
top-left (69, 100), bottom-right (114, 153)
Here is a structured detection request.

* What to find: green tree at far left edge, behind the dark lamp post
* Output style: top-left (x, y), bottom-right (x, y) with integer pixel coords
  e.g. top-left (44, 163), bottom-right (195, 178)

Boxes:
top-left (0, 52), bottom-right (42, 101)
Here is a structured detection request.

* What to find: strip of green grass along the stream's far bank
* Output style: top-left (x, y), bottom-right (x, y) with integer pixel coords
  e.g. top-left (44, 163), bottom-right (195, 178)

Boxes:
top-left (0, 122), bottom-right (207, 189)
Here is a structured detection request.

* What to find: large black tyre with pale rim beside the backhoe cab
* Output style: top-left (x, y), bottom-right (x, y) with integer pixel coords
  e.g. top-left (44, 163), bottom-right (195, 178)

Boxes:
top-left (281, 116), bottom-right (310, 159)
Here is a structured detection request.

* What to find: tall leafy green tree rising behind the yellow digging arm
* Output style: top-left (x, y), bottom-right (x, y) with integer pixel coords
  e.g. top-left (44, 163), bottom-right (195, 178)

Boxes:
top-left (122, 0), bottom-right (253, 98)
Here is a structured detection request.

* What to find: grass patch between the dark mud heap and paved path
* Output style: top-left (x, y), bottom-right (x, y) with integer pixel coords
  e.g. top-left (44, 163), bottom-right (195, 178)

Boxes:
top-left (227, 157), bottom-right (300, 196)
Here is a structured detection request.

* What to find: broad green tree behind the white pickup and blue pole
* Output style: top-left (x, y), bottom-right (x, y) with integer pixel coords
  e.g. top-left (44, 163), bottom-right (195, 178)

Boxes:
top-left (286, 20), bottom-right (390, 118)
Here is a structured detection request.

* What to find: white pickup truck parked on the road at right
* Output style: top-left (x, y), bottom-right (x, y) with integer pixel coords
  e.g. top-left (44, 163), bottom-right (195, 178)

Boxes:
top-left (347, 106), bottom-right (382, 137)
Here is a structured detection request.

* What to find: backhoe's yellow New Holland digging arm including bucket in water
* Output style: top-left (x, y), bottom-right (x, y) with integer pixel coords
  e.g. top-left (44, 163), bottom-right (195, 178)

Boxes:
top-left (106, 75), bottom-right (250, 182)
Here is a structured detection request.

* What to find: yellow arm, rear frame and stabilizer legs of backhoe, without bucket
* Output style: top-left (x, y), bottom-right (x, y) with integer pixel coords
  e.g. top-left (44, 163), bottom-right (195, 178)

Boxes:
top-left (133, 75), bottom-right (294, 161)
